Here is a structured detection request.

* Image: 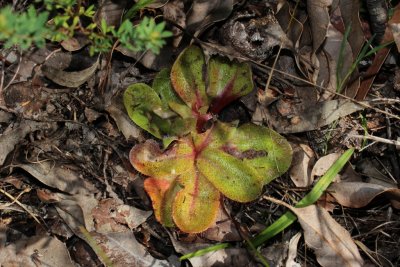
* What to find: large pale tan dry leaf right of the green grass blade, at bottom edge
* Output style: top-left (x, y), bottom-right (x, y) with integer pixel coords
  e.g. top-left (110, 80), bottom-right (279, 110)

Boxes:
top-left (291, 205), bottom-right (363, 267)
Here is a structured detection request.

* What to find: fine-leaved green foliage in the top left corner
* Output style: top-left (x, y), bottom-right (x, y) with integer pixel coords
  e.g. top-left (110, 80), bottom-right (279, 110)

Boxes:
top-left (0, 0), bottom-right (172, 55)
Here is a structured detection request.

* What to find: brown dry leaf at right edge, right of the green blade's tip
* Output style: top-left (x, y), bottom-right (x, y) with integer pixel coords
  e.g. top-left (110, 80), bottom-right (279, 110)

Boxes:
top-left (328, 182), bottom-right (400, 208)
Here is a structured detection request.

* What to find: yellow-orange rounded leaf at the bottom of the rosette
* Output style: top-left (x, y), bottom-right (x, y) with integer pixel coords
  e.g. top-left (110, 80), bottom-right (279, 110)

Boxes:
top-left (172, 168), bottom-right (220, 233)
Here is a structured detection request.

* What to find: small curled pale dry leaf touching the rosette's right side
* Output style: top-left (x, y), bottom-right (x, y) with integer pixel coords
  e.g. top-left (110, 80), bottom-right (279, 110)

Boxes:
top-left (289, 143), bottom-right (315, 187)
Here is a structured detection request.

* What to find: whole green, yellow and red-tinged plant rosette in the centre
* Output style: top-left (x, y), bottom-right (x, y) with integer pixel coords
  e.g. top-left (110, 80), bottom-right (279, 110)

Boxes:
top-left (124, 46), bottom-right (292, 233)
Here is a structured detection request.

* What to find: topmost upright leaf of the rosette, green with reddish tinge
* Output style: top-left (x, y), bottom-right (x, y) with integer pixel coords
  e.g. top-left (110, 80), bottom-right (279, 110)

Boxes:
top-left (171, 46), bottom-right (208, 113)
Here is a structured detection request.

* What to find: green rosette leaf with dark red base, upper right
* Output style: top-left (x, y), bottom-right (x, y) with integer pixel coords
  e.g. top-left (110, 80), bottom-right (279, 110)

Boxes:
top-left (207, 57), bottom-right (253, 114)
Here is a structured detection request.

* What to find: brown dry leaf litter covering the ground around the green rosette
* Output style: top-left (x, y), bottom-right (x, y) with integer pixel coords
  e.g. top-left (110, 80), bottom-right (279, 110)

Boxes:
top-left (0, 0), bottom-right (400, 266)
